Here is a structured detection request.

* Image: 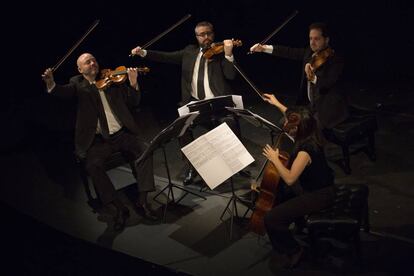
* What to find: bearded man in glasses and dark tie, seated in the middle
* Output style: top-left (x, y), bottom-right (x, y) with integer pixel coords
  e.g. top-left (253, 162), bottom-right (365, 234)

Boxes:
top-left (131, 21), bottom-right (240, 185)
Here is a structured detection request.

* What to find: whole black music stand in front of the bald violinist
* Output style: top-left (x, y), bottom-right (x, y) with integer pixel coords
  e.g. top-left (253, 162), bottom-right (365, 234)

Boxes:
top-left (135, 113), bottom-right (206, 221)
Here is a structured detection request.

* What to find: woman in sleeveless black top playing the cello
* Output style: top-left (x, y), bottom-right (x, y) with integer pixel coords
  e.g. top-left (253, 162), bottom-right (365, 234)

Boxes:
top-left (263, 94), bottom-right (334, 268)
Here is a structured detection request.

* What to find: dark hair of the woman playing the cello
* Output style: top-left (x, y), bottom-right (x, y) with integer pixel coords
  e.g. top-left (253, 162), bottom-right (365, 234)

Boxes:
top-left (284, 106), bottom-right (323, 152)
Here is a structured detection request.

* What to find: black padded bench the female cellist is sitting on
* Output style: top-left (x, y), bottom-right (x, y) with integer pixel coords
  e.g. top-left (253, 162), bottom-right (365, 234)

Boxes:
top-left (306, 184), bottom-right (370, 262)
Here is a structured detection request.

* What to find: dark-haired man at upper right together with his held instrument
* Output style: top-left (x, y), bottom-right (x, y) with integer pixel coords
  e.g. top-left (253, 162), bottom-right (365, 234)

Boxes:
top-left (250, 23), bottom-right (348, 130)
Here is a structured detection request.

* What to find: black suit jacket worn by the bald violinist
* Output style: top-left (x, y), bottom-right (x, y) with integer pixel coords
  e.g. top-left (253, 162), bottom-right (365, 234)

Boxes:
top-left (51, 75), bottom-right (141, 157)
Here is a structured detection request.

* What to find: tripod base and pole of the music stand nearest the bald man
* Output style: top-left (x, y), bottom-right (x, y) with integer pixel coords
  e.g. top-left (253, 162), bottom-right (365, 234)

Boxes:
top-left (153, 146), bottom-right (207, 222)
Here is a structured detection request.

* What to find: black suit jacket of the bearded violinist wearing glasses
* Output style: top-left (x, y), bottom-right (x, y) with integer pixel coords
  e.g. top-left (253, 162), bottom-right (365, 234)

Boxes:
top-left (145, 45), bottom-right (237, 105)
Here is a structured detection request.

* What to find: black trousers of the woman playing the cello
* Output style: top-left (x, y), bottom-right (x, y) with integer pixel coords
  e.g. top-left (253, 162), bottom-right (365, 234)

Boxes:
top-left (264, 185), bottom-right (335, 255)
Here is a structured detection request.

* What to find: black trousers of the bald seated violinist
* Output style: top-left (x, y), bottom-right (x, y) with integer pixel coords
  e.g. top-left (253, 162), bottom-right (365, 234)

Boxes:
top-left (85, 130), bottom-right (154, 204)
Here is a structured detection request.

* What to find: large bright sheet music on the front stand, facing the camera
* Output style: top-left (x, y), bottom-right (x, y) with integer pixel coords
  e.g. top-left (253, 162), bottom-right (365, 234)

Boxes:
top-left (181, 123), bottom-right (254, 189)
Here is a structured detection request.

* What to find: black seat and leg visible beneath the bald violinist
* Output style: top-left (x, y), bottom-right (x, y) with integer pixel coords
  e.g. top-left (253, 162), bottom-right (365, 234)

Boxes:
top-left (76, 152), bottom-right (135, 212)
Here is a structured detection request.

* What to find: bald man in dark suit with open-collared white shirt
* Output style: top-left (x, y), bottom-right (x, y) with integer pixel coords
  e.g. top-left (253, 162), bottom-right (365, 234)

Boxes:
top-left (42, 53), bottom-right (156, 230)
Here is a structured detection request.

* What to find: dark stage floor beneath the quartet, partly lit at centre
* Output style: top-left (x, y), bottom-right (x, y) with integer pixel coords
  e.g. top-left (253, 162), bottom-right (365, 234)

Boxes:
top-left (0, 81), bottom-right (414, 275)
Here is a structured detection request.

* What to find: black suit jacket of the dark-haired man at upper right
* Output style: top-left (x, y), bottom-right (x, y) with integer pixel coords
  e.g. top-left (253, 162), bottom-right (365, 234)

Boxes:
top-left (272, 45), bottom-right (349, 128)
